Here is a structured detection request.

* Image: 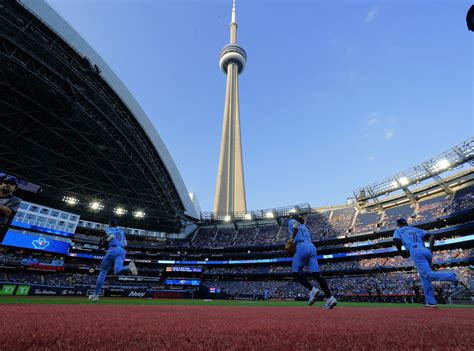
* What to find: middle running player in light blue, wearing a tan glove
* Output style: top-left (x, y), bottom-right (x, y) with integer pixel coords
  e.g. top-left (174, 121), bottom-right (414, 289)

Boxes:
top-left (288, 215), bottom-right (337, 309)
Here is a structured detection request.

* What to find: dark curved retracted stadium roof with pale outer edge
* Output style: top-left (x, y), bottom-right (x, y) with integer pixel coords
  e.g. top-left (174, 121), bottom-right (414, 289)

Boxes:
top-left (0, 0), bottom-right (198, 230)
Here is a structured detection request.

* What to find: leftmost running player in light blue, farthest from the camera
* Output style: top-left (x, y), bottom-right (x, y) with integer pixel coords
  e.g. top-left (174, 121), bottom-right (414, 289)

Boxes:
top-left (89, 219), bottom-right (138, 302)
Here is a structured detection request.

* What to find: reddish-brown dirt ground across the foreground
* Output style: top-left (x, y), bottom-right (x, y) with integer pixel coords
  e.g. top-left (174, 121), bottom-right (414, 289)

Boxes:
top-left (0, 305), bottom-right (474, 351)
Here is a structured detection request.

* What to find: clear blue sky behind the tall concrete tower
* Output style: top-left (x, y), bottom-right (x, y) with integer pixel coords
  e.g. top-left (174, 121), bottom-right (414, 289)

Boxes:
top-left (48, 0), bottom-right (474, 210)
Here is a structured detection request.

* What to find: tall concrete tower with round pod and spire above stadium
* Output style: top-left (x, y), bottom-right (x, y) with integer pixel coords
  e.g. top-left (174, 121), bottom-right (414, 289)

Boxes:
top-left (213, 0), bottom-right (247, 216)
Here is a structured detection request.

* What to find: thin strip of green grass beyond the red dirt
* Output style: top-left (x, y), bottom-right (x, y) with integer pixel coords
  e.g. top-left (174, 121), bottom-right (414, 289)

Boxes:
top-left (0, 296), bottom-right (474, 308)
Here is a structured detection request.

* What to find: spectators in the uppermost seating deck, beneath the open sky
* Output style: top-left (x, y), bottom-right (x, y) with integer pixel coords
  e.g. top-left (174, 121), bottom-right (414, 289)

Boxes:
top-left (182, 187), bottom-right (474, 247)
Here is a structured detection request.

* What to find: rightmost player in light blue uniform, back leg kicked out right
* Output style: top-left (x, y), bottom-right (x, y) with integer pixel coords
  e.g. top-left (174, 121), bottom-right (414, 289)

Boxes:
top-left (393, 218), bottom-right (470, 308)
